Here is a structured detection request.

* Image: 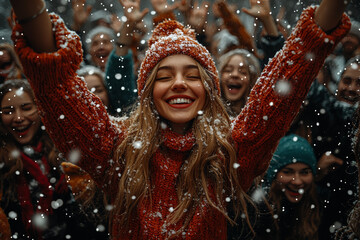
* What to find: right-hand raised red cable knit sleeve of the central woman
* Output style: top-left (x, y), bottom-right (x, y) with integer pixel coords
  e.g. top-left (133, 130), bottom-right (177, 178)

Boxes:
top-left (232, 6), bottom-right (351, 190)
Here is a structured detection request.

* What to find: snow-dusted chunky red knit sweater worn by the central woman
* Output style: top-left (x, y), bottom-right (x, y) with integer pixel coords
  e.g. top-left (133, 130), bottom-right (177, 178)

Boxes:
top-left (13, 7), bottom-right (350, 239)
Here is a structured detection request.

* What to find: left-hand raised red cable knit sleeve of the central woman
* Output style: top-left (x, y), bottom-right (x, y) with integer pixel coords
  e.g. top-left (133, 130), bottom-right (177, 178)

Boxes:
top-left (12, 14), bottom-right (120, 193)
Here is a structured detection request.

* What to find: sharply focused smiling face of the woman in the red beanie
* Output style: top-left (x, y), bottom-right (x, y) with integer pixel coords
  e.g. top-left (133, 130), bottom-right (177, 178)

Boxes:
top-left (153, 55), bottom-right (206, 133)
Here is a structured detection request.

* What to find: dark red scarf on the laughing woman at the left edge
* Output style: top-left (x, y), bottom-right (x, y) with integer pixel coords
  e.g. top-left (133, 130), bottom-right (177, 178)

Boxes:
top-left (17, 142), bottom-right (67, 236)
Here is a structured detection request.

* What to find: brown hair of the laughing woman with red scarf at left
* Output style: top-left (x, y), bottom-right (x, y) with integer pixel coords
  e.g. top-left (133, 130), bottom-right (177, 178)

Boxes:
top-left (0, 79), bottom-right (60, 207)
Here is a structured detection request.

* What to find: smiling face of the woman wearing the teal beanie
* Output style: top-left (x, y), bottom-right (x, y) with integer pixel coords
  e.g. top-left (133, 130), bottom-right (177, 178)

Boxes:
top-left (275, 163), bottom-right (313, 203)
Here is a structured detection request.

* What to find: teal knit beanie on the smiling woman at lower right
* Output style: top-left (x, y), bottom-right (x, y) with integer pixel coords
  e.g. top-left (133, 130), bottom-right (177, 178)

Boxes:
top-left (265, 134), bottom-right (316, 184)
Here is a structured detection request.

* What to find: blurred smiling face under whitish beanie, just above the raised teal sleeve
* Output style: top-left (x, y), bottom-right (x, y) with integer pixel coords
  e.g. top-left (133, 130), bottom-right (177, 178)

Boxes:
top-left (90, 34), bottom-right (114, 71)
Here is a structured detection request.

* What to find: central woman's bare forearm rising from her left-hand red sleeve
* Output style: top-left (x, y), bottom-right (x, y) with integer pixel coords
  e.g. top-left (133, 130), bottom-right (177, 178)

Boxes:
top-left (10, 0), bottom-right (56, 53)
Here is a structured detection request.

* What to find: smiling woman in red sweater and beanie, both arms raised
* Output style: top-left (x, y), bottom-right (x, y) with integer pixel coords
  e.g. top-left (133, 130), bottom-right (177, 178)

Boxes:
top-left (10, 0), bottom-right (350, 239)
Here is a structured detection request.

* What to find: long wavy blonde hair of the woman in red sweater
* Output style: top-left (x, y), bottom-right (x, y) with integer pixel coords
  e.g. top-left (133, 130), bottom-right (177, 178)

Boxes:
top-left (110, 60), bottom-right (249, 236)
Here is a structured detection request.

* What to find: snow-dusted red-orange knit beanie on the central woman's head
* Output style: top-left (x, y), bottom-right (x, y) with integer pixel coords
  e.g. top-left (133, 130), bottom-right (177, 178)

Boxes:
top-left (137, 20), bottom-right (220, 96)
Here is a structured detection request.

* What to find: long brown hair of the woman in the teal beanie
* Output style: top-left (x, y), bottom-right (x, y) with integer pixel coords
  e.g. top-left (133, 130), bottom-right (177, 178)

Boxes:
top-left (268, 180), bottom-right (320, 240)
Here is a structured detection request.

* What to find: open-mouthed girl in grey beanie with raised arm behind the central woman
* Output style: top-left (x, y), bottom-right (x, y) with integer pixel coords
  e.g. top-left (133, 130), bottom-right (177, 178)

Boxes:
top-left (218, 0), bottom-right (283, 117)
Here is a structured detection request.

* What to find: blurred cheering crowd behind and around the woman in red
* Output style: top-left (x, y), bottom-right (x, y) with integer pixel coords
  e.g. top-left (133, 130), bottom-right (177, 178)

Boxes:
top-left (0, 0), bottom-right (360, 240)
